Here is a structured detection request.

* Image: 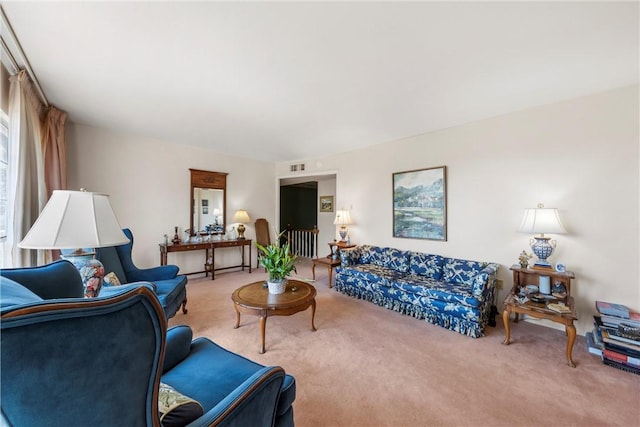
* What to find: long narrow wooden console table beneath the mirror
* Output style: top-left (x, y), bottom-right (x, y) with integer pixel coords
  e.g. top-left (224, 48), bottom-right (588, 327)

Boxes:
top-left (160, 239), bottom-right (251, 280)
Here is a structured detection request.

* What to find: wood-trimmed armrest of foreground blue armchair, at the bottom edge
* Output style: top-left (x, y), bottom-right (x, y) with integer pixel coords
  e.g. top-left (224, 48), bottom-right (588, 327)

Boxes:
top-left (189, 366), bottom-right (285, 427)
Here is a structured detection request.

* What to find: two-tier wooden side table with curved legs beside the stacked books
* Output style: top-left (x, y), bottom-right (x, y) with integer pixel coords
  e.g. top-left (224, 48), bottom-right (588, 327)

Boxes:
top-left (502, 265), bottom-right (578, 368)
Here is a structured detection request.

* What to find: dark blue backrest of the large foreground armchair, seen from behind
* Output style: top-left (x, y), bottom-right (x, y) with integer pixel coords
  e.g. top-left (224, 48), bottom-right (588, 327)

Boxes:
top-left (0, 280), bottom-right (166, 427)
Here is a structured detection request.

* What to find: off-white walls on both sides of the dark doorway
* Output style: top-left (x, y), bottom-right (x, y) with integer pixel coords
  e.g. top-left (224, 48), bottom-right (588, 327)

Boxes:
top-left (68, 86), bottom-right (640, 334)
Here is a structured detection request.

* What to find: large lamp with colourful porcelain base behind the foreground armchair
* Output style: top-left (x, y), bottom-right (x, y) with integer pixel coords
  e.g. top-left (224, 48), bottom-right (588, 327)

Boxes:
top-left (18, 190), bottom-right (129, 297)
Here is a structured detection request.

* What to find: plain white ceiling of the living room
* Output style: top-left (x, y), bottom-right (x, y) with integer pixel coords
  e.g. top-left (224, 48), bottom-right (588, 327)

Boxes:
top-left (2, 1), bottom-right (639, 161)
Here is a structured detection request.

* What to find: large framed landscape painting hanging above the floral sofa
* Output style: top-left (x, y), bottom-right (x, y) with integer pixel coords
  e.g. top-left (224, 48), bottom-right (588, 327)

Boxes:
top-left (393, 166), bottom-right (447, 241)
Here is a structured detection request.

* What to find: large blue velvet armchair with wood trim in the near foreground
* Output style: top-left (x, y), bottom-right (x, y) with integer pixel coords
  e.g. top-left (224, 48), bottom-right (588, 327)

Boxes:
top-left (0, 261), bottom-right (296, 427)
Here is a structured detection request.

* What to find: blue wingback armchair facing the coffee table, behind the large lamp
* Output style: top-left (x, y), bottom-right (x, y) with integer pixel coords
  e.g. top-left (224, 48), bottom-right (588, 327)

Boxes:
top-left (96, 228), bottom-right (187, 319)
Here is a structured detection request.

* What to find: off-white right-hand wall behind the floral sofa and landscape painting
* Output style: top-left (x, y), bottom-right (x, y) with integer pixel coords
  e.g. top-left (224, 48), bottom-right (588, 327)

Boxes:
top-left (276, 86), bottom-right (640, 334)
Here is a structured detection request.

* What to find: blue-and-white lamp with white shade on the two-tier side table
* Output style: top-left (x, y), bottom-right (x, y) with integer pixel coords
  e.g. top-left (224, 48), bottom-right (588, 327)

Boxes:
top-left (518, 203), bottom-right (567, 269)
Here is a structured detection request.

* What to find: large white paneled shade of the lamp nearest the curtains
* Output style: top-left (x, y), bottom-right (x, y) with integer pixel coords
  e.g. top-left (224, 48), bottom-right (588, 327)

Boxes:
top-left (18, 190), bottom-right (129, 249)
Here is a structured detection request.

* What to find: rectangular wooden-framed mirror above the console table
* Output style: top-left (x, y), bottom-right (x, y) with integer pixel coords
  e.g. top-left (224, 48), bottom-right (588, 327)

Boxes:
top-left (189, 169), bottom-right (228, 235)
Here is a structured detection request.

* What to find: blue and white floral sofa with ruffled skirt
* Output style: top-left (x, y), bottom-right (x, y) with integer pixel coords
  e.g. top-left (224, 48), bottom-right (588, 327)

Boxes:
top-left (334, 245), bottom-right (498, 338)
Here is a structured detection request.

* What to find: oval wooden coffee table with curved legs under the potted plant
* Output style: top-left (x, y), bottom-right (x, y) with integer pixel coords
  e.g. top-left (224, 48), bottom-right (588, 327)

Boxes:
top-left (231, 280), bottom-right (316, 353)
